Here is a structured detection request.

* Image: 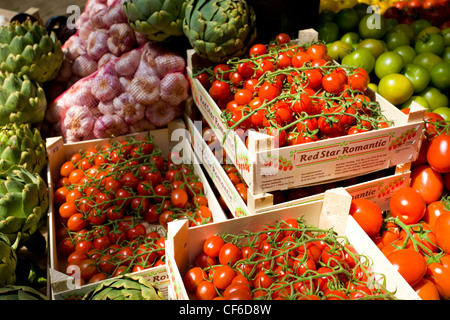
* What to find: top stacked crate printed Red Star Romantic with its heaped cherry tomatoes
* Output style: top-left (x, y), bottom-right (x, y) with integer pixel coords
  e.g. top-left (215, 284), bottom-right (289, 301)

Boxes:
top-left (187, 29), bottom-right (425, 194)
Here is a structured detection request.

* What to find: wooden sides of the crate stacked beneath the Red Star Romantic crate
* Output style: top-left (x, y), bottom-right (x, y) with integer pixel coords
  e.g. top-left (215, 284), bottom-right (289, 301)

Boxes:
top-left (184, 114), bottom-right (411, 217)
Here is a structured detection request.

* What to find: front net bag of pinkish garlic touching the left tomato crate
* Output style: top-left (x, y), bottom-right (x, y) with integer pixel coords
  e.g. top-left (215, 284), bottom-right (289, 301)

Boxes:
top-left (44, 42), bottom-right (190, 142)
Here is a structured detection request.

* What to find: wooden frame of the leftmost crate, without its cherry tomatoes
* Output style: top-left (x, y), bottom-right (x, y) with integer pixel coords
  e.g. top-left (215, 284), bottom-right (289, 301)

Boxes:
top-left (47, 120), bottom-right (227, 300)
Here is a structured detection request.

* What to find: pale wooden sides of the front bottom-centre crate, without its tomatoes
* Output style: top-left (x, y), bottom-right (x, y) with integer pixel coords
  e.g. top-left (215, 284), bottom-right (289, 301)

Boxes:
top-left (166, 188), bottom-right (420, 300)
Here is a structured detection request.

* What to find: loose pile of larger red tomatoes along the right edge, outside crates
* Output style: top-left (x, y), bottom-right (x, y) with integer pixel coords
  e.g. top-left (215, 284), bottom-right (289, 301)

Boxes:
top-left (353, 113), bottom-right (450, 300)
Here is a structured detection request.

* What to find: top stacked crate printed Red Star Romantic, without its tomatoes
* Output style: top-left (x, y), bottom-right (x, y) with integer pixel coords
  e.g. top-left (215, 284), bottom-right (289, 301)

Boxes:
top-left (187, 29), bottom-right (425, 194)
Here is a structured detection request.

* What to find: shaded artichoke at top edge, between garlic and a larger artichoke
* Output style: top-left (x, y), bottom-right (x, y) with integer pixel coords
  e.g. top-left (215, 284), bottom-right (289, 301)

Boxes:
top-left (123, 0), bottom-right (187, 41)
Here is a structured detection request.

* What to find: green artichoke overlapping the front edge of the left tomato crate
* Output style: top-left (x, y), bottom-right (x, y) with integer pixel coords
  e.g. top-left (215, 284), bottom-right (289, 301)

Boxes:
top-left (82, 274), bottom-right (164, 300)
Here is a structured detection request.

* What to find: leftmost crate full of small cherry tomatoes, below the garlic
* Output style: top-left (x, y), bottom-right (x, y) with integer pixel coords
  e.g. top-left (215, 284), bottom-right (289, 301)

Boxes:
top-left (47, 120), bottom-right (226, 299)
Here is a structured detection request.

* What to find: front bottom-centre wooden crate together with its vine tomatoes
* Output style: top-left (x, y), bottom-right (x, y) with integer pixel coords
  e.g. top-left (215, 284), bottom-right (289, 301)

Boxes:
top-left (166, 188), bottom-right (418, 300)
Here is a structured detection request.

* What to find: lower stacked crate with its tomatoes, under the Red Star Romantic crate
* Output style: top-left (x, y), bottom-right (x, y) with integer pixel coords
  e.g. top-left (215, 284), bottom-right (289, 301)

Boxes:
top-left (185, 114), bottom-right (411, 217)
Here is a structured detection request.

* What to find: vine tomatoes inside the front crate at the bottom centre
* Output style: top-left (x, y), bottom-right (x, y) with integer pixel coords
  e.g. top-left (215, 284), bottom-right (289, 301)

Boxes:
top-left (183, 218), bottom-right (393, 300)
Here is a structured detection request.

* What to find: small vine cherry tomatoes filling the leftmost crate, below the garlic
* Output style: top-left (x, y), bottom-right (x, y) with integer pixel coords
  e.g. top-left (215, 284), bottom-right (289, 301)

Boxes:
top-left (54, 135), bottom-right (212, 283)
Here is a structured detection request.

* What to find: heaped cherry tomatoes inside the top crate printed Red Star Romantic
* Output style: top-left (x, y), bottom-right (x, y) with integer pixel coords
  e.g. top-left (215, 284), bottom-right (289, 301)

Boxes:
top-left (195, 33), bottom-right (390, 147)
